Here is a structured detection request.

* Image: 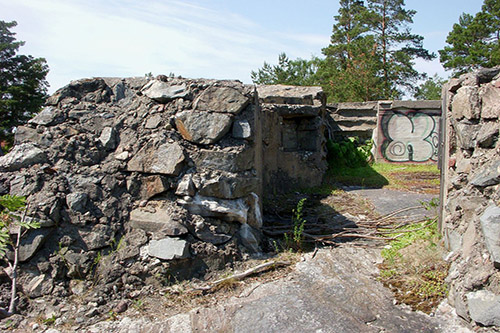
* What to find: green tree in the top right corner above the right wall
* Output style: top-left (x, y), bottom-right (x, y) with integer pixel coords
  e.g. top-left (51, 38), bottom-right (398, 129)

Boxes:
top-left (439, 0), bottom-right (500, 76)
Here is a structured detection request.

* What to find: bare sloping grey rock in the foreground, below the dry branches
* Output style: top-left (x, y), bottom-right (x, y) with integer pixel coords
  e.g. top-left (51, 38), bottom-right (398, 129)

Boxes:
top-left (88, 246), bottom-right (467, 332)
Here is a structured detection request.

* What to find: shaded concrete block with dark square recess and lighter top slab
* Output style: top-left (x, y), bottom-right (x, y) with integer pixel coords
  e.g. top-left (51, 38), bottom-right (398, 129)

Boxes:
top-left (257, 85), bottom-right (327, 197)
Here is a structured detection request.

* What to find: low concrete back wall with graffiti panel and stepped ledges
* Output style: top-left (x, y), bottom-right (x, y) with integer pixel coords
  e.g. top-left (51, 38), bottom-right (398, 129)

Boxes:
top-left (327, 101), bottom-right (441, 163)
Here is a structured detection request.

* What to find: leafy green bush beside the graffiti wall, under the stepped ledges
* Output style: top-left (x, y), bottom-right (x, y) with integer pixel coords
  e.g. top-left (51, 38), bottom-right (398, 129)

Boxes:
top-left (326, 137), bottom-right (373, 168)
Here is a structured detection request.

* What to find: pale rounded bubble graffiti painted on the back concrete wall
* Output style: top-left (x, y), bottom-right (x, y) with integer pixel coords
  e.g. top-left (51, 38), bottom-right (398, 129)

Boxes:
top-left (379, 110), bottom-right (439, 162)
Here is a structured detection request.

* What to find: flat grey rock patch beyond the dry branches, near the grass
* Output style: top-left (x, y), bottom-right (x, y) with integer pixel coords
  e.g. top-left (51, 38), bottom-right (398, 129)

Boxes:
top-left (343, 186), bottom-right (438, 220)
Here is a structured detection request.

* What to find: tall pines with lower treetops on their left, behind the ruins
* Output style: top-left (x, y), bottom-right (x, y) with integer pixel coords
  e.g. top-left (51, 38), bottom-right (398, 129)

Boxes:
top-left (252, 0), bottom-right (435, 102)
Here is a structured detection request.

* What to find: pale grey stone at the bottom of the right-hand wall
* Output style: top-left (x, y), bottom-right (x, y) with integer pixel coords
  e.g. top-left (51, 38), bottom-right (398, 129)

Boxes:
top-left (467, 290), bottom-right (500, 326)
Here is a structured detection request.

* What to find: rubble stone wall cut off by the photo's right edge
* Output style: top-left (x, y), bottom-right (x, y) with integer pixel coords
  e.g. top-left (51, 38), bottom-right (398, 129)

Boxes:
top-left (441, 68), bottom-right (500, 326)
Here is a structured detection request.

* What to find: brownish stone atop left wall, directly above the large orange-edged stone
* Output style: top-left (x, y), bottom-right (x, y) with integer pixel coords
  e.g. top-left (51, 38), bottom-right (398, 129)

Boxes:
top-left (194, 86), bottom-right (250, 114)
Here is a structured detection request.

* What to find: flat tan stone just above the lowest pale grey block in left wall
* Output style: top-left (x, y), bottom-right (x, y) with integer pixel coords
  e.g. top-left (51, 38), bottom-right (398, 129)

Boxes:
top-left (130, 208), bottom-right (188, 236)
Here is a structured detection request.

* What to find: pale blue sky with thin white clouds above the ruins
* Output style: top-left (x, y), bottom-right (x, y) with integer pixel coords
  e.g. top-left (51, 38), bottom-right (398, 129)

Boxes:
top-left (0, 0), bottom-right (483, 92)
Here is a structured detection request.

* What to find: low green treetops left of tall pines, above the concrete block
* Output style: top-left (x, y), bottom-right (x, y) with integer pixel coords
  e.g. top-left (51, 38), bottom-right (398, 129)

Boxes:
top-left (250, 53), bottom-right (318, 86)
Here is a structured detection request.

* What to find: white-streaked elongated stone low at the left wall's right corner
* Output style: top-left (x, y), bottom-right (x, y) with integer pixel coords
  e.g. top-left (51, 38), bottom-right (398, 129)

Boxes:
top-left (181, 194), bottom-right (248, 223)
